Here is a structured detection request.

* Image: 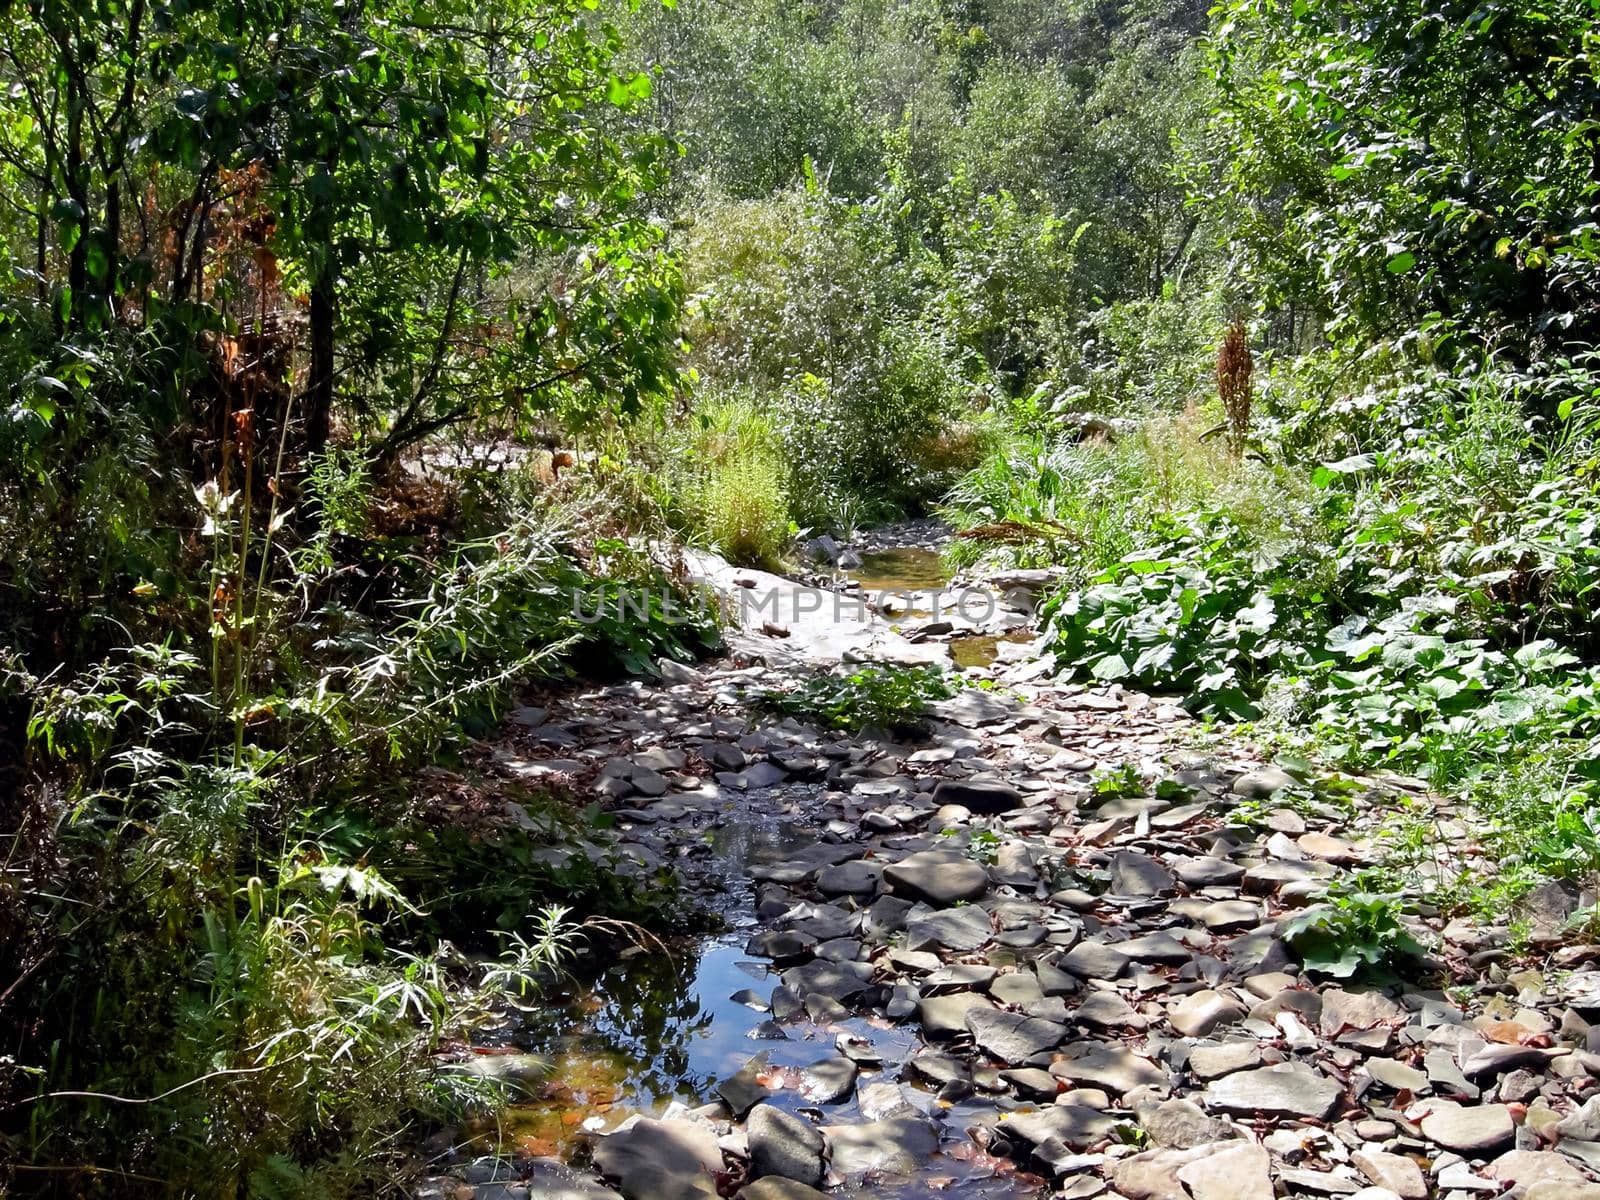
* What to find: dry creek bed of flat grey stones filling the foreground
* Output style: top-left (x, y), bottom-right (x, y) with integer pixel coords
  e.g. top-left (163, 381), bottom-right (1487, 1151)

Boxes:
top-left (416, 563), bottom-right (1600, 1200)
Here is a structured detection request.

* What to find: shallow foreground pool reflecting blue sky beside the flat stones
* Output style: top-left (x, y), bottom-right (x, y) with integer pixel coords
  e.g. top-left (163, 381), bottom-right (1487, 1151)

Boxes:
top-left (474, 813), bottom-right (1040, 1200)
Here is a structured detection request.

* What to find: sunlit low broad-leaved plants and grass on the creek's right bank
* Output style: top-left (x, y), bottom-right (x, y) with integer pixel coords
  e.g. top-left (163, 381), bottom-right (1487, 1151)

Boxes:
top-left (950, 347), bottom-right (1600, 917)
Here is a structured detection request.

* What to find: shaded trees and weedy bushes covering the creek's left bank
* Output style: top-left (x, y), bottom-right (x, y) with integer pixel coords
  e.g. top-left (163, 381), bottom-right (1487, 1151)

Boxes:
top-left (0, 0), bottom-right (715, 1195)
